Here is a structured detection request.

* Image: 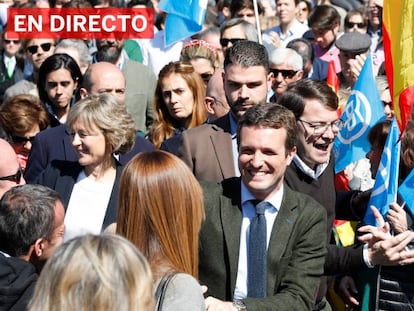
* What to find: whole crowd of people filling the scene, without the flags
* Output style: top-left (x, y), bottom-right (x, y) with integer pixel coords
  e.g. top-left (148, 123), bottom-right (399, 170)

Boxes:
top-left (0, 0), bottom-right (414, 311)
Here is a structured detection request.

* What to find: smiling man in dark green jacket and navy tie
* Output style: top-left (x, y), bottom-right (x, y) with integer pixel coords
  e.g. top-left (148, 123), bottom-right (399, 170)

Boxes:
top-left (199, 104), bottom-right (326, 311)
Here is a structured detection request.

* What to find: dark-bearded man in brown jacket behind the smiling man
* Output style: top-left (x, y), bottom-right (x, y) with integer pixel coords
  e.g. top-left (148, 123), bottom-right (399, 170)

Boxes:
top-left (178, 40), bottom-right (273, 182)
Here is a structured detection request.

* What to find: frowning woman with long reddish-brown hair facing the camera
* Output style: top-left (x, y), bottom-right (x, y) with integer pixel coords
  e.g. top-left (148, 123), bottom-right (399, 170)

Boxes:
top-left (149, 61), bottom-right (207, 148)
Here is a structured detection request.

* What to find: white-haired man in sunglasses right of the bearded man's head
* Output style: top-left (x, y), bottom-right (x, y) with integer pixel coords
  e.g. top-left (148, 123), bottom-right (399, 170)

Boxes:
top-left (269, 48), bottom-right (303, 102)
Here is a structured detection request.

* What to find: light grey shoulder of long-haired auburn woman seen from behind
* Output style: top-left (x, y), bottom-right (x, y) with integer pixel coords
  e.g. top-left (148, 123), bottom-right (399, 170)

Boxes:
top-left (162, 273), bottom-right (205, 311)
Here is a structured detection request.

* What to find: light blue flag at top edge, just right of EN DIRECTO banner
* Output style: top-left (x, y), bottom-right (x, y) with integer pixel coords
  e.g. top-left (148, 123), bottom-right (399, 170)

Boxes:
top-left (159, 0), bottom-right (208, 46)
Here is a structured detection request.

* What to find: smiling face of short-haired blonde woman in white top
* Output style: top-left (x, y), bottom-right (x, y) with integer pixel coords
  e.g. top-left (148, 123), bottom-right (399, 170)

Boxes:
top-left (71, 121), bottom-right (110, 167)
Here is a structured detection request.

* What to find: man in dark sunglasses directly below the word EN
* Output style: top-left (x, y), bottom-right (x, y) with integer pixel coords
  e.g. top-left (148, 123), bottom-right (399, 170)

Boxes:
top-left (23, 39), bottom-right (56, 83)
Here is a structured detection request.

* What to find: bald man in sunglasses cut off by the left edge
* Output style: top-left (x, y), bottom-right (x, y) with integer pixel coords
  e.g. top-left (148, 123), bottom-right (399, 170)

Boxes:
top-left (0, 138), bottom-right (26, 198)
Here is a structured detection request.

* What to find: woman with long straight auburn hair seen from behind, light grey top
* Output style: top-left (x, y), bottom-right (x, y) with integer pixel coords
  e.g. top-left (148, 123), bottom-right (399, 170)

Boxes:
top-left (117, 150), bottom-right (205, 310)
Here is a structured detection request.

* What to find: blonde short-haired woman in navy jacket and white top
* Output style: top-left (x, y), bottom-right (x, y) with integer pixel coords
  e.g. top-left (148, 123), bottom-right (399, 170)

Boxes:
top-left (36, 93), bottom-right (136, 240)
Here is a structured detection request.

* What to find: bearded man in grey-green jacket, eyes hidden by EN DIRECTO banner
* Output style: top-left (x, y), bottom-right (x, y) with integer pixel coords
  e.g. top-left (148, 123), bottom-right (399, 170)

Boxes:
top-left (93, 39), bottom-right (157, 136)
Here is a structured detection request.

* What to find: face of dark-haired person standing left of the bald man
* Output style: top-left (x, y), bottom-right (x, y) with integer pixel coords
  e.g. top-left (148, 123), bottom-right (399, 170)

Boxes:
top-left (45, 68), bottom-right (78, 109)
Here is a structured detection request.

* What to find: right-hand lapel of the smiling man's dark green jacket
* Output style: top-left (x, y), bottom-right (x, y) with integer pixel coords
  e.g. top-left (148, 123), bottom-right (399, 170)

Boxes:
top-left (267, 185), bottom-right (299, 294)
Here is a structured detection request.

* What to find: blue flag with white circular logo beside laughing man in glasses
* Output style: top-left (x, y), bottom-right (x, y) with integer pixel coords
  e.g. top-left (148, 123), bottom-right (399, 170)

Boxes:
top-left (333, 55), bottom-right (385, 173)
